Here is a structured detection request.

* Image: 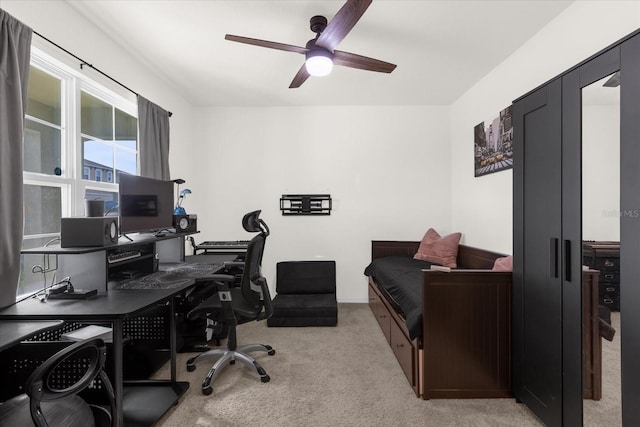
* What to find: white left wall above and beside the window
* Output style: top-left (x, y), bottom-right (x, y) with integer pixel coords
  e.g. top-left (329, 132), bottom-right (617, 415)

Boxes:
top-left (0, 0), bottom-right (196, 187)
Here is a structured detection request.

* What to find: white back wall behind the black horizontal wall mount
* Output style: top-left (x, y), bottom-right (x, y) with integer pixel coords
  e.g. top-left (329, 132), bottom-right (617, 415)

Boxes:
top-left (187, 107), bottom-right (451, 302)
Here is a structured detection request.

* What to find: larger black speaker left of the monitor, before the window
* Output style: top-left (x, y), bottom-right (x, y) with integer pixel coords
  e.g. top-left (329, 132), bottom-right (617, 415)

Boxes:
top-left (60, 216), bottom-right (118, 248)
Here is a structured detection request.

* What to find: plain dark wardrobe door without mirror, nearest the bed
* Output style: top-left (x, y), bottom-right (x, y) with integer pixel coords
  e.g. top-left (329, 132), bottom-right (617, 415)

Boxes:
top-left (512, 79), bottom-right (563, 426)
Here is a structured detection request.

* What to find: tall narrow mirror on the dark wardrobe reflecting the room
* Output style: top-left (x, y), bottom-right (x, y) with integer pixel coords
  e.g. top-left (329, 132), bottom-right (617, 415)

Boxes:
top-left (582, 72), bottom-right (624, 426)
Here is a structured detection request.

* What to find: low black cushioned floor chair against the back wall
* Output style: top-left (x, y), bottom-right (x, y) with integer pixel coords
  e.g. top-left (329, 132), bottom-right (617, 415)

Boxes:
top-left (267, 261), bottom-right (338, 326)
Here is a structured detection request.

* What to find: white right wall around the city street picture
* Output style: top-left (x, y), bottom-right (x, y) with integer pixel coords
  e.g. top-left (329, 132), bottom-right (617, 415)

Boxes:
top-left (451, 1), bottom-right (640, 253)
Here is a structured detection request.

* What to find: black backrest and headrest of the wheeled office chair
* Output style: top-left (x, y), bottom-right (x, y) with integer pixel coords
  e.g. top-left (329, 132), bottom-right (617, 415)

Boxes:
top-left (240, 210), bottom-right (273, 320)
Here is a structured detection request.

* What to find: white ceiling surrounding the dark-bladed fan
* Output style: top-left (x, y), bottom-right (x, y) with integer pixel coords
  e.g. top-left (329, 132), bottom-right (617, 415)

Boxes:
top-left (69, 0), bottom-right (572, 106)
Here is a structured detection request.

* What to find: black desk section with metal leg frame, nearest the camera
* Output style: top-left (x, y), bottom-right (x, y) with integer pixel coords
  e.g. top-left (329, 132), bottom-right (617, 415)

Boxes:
top-left (0, 280), bottom-right (195, 426)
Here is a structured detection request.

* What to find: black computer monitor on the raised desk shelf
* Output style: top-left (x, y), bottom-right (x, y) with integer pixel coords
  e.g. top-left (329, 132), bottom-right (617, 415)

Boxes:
top-left (118, 173), bottom-right (174, 234)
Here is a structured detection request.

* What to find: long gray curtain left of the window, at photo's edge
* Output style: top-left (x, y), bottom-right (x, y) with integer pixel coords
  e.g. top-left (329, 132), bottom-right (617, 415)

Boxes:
top-left (0, 9), bottom-right (32, 307)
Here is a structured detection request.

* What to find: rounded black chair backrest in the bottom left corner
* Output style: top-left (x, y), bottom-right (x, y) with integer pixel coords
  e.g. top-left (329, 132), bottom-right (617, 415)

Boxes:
top-left (25, 338), bottom-right (116, 426)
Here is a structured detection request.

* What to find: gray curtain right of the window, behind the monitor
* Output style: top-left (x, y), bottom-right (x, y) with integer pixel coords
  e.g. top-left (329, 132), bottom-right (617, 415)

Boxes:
top-left (138, 95), bottom-right (171, 181)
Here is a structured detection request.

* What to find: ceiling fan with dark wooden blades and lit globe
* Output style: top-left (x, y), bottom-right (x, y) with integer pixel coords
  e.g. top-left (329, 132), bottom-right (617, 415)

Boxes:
top-left (224, 0), bottom-right (396, 88)
